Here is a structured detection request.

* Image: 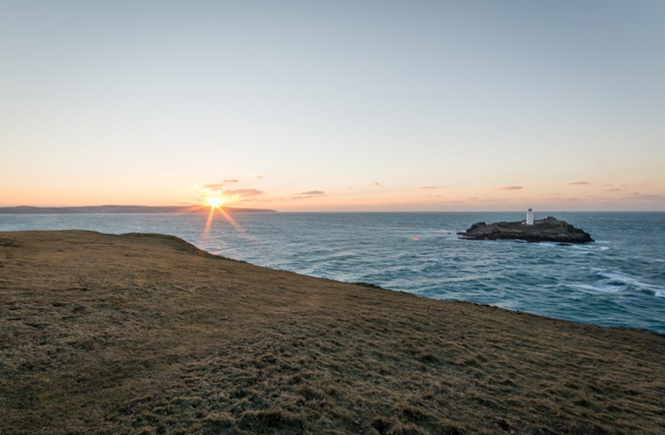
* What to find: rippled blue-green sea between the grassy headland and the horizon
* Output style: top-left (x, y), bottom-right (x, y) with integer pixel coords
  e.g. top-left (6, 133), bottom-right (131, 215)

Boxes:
top-left (0, 212), bottom-right (665, 333)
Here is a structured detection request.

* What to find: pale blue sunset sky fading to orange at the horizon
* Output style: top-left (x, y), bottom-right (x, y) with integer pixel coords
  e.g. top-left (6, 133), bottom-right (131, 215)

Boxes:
top-left (0, 0), bottom-right (665, 211)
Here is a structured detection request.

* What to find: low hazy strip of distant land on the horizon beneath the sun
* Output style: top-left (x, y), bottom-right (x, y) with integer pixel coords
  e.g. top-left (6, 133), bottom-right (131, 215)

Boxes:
top-left (0, 205), bottom-right (277, 214)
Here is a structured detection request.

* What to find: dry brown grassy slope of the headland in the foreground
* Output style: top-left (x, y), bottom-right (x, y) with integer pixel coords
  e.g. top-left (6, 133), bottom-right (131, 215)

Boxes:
top-left (0, 231), bottom-right (665, 434)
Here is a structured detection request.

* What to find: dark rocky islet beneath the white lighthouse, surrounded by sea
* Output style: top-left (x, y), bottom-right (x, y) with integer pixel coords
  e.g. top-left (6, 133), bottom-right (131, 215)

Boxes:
top-left (457, 216), bottom-right (593, 243)
